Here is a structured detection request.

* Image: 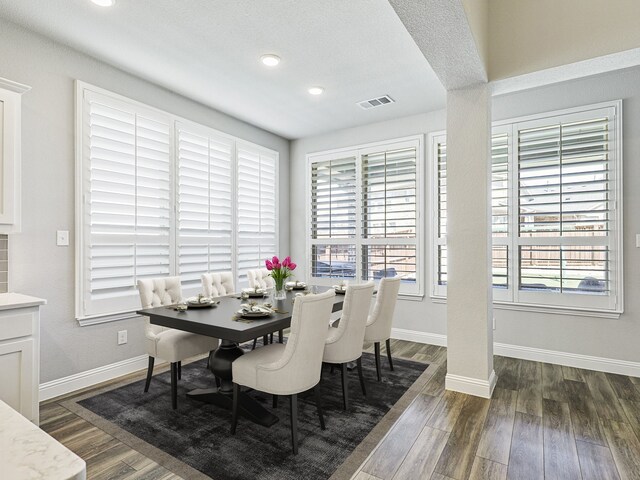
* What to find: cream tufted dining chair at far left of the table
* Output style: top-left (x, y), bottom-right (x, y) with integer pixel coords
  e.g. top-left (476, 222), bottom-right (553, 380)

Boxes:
top-left (138, 277), bottom-right (219, 409)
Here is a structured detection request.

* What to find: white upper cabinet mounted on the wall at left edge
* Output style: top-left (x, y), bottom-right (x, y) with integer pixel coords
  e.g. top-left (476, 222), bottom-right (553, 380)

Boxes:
top-left (0, 78), bottom-right (29, 233)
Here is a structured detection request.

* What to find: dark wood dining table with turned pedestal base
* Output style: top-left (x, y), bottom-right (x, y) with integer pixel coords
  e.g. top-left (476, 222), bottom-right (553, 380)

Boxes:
top-left (136, 287), bottom-right (344, 426)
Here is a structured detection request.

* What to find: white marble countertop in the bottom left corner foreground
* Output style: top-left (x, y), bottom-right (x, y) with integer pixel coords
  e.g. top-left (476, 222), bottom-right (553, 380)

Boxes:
top-left (0, 401), bottom-right (87, 480)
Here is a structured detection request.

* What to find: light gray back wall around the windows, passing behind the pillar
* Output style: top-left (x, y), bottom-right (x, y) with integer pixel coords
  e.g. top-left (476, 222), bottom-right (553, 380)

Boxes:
top-left (291, 64), bottom-right (640, 362)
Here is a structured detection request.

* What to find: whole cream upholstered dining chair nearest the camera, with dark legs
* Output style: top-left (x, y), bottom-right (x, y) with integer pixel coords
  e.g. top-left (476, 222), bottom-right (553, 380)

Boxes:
top-left (231, 290), bottom-right (335, 454)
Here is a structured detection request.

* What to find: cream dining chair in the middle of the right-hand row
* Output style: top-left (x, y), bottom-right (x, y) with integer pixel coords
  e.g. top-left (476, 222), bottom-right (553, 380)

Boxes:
top-left (322, 282), bottom-right (374, 410)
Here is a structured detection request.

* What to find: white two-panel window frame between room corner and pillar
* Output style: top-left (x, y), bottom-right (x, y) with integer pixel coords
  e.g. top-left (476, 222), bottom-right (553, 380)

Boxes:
top-left (305, 134), bottom-right (427, 300)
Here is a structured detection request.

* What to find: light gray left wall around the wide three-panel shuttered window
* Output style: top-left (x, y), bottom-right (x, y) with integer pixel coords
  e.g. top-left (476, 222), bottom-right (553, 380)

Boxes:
top-left (0, 20), bottom-right (289, 382)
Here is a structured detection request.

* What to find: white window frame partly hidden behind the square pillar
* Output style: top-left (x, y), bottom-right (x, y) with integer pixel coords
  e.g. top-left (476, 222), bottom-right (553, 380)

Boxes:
top-left (428, 100), bottom-right (624, 318)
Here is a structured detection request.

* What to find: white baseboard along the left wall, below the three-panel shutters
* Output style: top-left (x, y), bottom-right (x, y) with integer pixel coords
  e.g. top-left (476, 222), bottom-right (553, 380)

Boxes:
top-left (40, 354), bottom-right (149, 402)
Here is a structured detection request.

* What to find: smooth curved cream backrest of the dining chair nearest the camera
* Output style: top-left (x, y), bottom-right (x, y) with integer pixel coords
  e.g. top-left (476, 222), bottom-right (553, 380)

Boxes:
top-left (256, 290), bottom-right (335, 395)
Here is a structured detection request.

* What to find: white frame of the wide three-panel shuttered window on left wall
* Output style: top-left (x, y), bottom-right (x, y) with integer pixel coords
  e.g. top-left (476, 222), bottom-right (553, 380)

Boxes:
top-left (75, 80), bottom-right (280, 326)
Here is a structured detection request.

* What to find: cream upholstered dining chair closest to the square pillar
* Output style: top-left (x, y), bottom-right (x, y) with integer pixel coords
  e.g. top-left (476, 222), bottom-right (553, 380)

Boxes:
top-left (364, 277), bottom-right (400, 381)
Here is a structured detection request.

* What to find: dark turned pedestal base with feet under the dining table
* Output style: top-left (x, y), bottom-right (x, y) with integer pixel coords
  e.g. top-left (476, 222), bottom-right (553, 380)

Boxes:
top-left (187, 340), bottom-right (278, 427)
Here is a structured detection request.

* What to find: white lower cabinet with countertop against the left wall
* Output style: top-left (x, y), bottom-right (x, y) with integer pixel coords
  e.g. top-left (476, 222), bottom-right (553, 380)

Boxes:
top-left (0, 293), bottom-right (45, 424)
